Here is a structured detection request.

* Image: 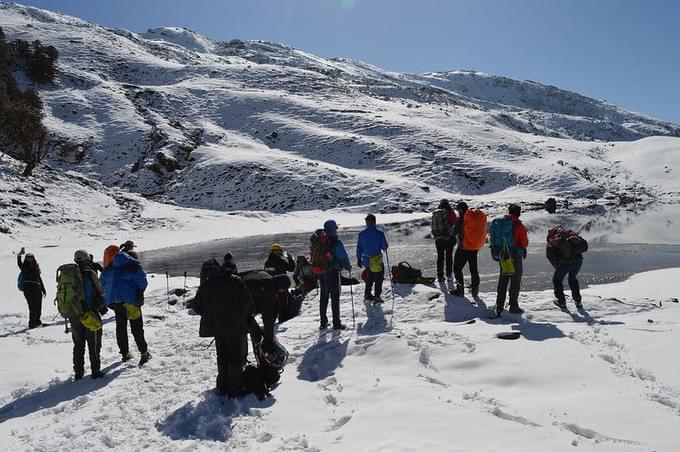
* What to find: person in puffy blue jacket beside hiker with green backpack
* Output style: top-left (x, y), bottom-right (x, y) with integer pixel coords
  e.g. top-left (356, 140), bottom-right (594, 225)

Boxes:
top-left (101, 245), bottom-right (151, 366)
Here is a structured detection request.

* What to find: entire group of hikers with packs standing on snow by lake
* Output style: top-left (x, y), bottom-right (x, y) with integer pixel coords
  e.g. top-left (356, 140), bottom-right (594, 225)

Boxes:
top-left (17, 199), bottom-right (587, 397)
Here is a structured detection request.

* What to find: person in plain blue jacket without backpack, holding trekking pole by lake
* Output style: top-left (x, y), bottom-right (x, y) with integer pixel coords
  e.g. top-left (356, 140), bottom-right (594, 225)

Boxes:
top-left (357, 213), bottom-right (388, 304)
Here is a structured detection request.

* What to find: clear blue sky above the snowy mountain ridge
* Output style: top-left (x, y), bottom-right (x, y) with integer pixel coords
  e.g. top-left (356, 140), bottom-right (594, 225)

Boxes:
top-left (11, 0), bottom-right (680, 123)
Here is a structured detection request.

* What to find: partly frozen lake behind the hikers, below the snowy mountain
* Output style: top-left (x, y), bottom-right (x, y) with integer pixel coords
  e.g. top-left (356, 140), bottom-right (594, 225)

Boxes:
top-left (140, 204), bottom-right (680, 291)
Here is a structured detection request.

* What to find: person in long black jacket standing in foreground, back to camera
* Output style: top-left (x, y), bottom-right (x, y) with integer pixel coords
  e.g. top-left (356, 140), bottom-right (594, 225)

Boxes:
top-left (193, 259), bottom-right (255, 397)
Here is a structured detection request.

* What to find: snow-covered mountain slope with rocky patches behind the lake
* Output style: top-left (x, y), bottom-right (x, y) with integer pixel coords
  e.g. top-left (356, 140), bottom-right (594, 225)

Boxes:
top-left (0, 3), bottom-right (680, 225)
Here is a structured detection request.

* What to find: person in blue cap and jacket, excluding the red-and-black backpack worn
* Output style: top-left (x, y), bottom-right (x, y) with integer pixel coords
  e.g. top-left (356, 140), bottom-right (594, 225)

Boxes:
top-left (319, 220), bottom-right (352, 330)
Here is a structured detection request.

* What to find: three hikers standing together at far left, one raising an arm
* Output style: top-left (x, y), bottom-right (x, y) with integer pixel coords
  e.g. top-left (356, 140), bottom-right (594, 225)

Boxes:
top-left (17, 240), bottom-right (151, 380)
